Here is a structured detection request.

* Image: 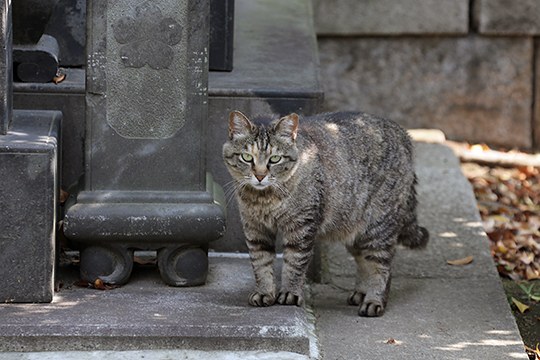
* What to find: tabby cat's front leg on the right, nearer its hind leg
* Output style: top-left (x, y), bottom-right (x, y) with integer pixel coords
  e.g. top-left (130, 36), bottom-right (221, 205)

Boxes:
top-left (277, 229), bottom-right (315, 306)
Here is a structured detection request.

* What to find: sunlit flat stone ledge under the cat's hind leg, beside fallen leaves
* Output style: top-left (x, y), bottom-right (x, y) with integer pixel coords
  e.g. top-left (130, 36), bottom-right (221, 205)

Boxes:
top-left (312, 143), bottom-right (527, 360)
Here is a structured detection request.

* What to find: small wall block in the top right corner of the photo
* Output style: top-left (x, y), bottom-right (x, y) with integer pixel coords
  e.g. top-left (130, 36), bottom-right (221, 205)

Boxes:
top-left (475, 0), bottom-right (540, 35)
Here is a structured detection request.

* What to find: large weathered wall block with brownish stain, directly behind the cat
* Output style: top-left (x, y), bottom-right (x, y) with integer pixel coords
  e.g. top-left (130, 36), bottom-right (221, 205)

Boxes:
top-left (319, 37), bottom-right (533, 148)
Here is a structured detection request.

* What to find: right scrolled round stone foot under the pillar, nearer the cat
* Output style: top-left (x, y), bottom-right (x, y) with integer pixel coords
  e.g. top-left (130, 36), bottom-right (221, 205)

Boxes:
top-left (158, 246), bottom-right (208, 286)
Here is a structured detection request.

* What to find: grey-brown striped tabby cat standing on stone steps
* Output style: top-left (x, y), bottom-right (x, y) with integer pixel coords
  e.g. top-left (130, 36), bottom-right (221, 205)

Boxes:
top-left (223, 111), bottom-right (429, 316)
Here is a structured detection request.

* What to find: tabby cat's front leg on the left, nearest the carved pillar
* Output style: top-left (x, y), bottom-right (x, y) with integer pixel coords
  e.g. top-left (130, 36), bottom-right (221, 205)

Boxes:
top-left (244, 224), bottom-right (276, 306)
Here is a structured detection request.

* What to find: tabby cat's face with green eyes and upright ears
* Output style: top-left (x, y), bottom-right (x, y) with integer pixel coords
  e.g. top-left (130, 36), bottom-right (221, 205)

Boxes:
top-left (223, 111), bottom-right (298, 190)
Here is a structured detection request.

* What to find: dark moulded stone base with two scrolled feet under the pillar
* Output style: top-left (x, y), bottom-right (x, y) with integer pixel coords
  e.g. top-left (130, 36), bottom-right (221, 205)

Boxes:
top-left (64, 174), bottom-right (225, 286)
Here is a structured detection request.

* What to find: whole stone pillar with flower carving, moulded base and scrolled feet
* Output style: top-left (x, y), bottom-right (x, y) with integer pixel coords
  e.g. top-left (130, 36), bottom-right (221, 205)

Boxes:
top-left (64, 0), bottom-right (225, 286)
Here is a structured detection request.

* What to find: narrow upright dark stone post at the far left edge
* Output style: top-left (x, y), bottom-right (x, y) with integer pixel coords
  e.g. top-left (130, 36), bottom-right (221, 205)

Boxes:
top-left (0, 0), bottom-right (13, 135)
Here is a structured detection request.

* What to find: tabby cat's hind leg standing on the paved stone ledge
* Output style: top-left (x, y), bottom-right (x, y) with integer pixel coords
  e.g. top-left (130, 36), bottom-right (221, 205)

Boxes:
top-left (347, 242), bottom-right (394, 316)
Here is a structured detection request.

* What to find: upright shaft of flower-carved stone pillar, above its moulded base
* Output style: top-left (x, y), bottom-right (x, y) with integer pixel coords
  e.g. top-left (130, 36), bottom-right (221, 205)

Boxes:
top-left (85, 0), bottom-right (209, 191)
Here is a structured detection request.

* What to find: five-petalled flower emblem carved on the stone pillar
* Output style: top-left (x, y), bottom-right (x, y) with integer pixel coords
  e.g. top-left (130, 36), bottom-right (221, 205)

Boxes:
top-left (113, 1), bottom-right (182, 70)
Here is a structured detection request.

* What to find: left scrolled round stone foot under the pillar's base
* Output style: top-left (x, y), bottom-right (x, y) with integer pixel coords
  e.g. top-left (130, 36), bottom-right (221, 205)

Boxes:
top-left (80, 246), bottom-right (133, 285)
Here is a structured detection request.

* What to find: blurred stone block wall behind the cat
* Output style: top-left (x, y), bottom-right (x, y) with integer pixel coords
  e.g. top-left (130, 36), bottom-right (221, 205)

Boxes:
top-left (313, 0), bottom-right (540, 150)
